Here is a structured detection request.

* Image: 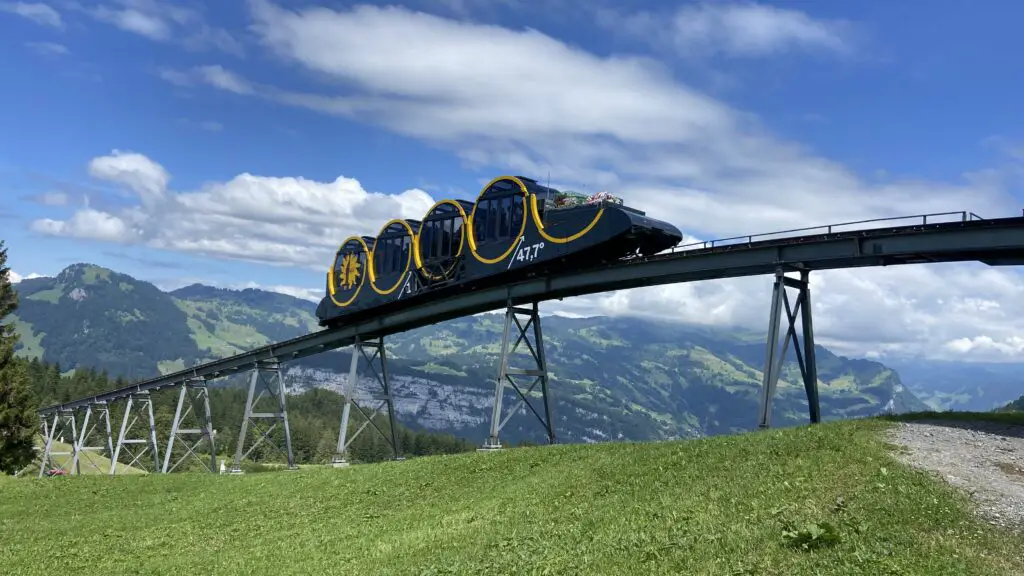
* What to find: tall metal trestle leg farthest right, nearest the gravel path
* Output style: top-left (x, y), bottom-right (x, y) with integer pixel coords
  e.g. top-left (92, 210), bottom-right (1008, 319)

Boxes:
top-left (758, 269), bottom-right (821, 428)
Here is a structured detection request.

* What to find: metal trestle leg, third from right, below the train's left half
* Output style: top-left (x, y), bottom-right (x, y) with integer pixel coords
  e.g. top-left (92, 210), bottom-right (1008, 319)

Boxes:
top-left (332, 336), bottom-right (404, 467)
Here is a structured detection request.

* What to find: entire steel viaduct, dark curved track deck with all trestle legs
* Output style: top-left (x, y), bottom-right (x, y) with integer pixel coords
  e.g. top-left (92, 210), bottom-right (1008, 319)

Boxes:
top-left (28, 208), bottom-right (1024, 477)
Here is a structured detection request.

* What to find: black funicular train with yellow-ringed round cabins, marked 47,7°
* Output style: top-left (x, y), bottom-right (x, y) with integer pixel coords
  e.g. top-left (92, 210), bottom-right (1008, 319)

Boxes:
top-left (316, 176), bottom-right (682, 327)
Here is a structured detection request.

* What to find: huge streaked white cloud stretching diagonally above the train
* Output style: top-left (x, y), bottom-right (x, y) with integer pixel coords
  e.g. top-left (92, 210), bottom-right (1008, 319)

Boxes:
top-left (176, 0), bottom-right (1013, 230)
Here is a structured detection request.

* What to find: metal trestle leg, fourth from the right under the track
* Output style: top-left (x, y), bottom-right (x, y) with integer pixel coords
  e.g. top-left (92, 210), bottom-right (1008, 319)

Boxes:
top-left (230, 362), bottom-right (297, 475)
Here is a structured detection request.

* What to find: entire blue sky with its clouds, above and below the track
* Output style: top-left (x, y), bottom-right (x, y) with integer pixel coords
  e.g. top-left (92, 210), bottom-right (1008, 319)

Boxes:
top-left (0, 0), bottom-right (1024, 359)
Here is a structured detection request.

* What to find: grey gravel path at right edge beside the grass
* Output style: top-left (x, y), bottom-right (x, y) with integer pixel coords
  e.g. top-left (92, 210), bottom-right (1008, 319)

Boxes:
top-left (890, 420), bottom-right (1024, 531)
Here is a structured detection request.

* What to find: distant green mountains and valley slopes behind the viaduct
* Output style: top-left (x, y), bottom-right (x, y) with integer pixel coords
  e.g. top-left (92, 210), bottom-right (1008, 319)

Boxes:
top-left (6, 264), bottom-right (1020, 442)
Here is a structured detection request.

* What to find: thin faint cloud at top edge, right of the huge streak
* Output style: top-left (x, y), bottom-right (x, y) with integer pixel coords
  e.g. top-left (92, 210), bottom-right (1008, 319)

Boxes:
top-left (597, 2), bottom-right (854, 57)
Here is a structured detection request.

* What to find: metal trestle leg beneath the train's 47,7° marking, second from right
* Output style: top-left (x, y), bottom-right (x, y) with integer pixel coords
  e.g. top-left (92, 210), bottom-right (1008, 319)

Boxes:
top-left (482, 302), bottom-right (555, 450)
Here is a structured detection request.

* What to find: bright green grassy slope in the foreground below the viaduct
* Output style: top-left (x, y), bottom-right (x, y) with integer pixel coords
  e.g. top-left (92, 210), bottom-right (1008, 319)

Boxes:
top-left (0, 420), bottom-right (1024, 575)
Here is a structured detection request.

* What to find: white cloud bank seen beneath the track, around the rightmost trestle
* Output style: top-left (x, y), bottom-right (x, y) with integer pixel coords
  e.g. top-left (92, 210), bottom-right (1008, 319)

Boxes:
top-left (547, 263), bottom-right (1024, 361)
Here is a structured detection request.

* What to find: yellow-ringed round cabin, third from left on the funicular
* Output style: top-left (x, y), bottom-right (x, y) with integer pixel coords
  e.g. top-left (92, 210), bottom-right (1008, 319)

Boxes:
top-left (414, 200), bottom-right (473, 285)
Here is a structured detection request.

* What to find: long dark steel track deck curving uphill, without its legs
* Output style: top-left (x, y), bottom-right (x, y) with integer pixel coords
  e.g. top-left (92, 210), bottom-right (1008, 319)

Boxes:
top-left (39, 212), bottom-right (1024, 415)
